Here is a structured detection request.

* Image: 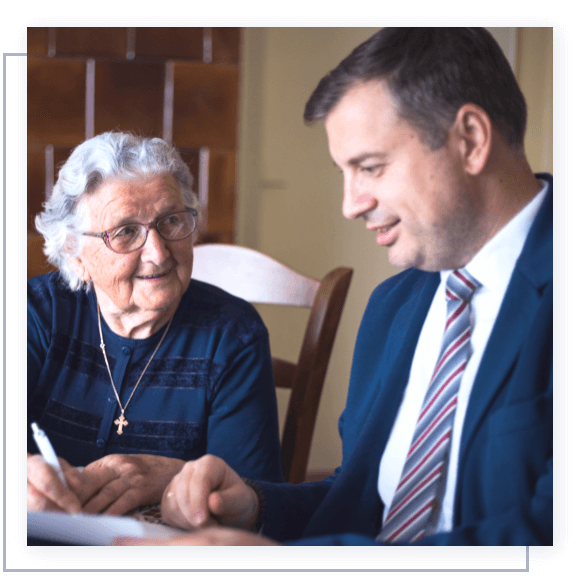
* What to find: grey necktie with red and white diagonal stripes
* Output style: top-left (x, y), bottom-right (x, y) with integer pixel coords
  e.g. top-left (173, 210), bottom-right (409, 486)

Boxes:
top-left (377, 270), bottom-right (480, 543)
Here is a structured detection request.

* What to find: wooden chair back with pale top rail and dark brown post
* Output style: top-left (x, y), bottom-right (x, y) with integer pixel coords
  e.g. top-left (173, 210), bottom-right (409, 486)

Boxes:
top-left (192, 244), bottom-right (353, 483)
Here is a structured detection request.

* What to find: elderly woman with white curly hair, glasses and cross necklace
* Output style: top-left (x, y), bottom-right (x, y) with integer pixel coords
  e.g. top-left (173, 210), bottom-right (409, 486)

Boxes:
top-left (27, 133), bottom-right (283, 514)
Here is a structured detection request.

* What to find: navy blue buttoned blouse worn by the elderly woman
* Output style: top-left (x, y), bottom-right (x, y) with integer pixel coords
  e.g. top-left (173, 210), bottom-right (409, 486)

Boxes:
top-left (27, 273), bottom-right (283, 481)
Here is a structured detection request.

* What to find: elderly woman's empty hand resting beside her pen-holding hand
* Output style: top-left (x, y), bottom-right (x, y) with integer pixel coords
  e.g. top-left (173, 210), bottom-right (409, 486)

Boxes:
top-left (79, 454), bottom-right (185, 515)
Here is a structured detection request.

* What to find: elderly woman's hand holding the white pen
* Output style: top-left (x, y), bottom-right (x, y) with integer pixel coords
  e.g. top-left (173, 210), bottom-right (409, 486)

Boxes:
top-left (26, 453), bottom-right (81, 513)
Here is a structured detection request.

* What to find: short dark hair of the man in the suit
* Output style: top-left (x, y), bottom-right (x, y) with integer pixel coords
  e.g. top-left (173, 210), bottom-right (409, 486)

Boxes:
top-left (304, 27), bottom-right (527, 149)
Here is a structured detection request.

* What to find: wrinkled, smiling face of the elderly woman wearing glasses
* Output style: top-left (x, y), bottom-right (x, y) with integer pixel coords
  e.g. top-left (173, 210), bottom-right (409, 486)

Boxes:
top-left (72, 176), bottom-right (193, 321)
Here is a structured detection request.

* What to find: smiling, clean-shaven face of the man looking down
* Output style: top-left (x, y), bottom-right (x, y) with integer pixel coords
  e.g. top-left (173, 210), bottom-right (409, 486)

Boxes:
top-left (325, 80), bottom-right (482, 271)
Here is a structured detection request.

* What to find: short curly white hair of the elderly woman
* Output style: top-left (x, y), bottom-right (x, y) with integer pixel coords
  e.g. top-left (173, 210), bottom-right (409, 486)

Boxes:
top-left (35, 133), bottom-right (197, 291)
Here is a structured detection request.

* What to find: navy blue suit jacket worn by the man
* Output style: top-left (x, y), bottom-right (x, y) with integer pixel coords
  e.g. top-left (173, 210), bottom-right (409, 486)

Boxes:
top-left (253, 175), bottom-right (553, 545)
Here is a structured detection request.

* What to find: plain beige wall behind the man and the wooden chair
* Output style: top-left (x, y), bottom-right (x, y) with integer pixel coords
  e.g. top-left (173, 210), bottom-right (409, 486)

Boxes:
top-left (236, 27), bottom-right (553, 470)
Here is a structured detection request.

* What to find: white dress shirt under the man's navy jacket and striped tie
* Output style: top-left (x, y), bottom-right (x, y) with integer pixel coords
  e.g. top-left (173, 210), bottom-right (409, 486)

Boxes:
top-left (378, 181), bottom-right (547, 533)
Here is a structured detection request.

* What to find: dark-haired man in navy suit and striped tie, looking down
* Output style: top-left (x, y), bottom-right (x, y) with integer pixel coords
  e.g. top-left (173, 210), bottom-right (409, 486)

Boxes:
top-left (120, 28), bottom-right (553, 545)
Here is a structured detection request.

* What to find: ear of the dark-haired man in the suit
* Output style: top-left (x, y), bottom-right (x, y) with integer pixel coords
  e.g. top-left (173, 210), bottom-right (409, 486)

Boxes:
top-left (452, 103), bottom-right (493, 175)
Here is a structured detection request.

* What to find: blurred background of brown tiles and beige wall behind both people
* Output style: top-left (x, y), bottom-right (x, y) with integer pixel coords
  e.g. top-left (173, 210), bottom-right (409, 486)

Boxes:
top-left (27, 27), bottom-right (553, 477)
